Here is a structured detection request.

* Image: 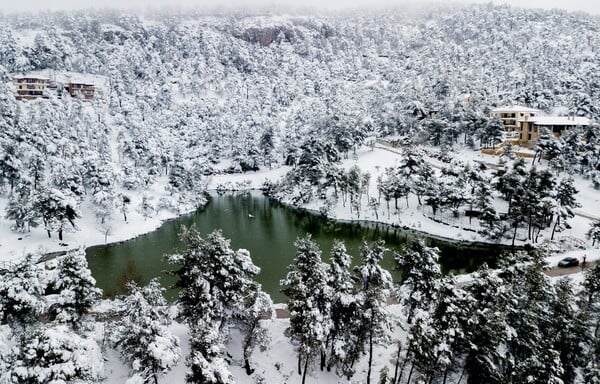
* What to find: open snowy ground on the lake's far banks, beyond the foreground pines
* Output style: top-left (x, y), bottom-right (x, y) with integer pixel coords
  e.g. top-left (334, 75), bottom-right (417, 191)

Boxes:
top-left (0, 145), bottom-right (600, 270)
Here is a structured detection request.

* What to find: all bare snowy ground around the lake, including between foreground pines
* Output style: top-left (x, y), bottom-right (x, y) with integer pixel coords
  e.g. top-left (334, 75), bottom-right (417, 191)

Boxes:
top-left (0, 147), bottom-right (600, 384)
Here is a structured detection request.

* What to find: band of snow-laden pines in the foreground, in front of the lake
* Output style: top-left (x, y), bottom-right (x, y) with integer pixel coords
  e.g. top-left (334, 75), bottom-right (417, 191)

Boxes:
top-left (0, 227), bottom-right (600, 384)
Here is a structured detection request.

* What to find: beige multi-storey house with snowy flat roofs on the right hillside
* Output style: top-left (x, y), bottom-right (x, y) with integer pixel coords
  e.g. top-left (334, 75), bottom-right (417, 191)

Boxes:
top-left (490, 105), bottom-right (590, 147)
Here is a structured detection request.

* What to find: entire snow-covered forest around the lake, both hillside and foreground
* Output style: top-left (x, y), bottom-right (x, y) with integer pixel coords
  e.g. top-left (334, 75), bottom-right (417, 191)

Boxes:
top-left (0, 4), bottom-right (600, 384)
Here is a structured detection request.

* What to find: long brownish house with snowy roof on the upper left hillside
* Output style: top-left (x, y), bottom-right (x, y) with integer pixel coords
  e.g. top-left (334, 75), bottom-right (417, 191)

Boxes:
top-left (12, 71), bottom-right (96, 100)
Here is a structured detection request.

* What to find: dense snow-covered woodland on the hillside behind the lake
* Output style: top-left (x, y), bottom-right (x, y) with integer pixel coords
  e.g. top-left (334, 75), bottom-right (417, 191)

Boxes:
top-left (0, 5), bottom-right (600, 240)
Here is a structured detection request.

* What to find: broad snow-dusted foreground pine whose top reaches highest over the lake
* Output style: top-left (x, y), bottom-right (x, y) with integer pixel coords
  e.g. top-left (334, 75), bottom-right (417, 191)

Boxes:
top-left (168, 226), bottom-right (272, 378)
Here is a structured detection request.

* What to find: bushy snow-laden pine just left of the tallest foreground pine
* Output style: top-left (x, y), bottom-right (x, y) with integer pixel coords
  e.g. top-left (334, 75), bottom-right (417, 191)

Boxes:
top-left (110, 279), bottom-right (181, 384)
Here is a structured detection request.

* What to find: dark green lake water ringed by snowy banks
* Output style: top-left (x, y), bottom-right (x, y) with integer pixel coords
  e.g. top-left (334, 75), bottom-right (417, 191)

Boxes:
top-left (87, 193), bottom-right (501, 302)
